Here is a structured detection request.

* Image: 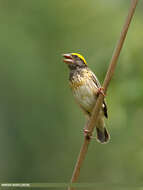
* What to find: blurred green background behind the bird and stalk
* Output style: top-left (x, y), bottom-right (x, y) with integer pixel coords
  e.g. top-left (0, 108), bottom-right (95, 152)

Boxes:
top-left (0, 0), bottom-right (143, 189)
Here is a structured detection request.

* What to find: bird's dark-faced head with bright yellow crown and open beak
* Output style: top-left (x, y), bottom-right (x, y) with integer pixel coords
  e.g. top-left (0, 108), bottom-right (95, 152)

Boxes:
top-left (63, 53), bottom-right (87, 70)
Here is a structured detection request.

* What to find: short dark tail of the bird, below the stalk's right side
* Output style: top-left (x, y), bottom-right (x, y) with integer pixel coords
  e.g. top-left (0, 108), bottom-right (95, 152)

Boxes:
top-left (96, 127), bottom-right (110, 144)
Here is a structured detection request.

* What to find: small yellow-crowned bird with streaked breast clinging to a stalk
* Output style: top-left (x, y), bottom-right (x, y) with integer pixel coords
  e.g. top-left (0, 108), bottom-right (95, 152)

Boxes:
top-left (63, 53), bottom-right (110, 143)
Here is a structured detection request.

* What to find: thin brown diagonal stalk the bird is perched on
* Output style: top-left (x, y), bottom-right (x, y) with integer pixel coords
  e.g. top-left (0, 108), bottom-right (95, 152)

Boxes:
top-left (68, 0), bottom-right (138, 190)
